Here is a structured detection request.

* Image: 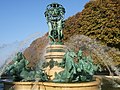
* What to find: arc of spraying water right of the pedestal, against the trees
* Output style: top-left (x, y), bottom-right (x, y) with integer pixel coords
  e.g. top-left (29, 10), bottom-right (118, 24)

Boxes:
top-left (65, 35), bottom-right (120, 76)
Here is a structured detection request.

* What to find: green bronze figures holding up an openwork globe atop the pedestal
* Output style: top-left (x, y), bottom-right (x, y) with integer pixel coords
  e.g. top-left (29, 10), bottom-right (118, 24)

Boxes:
top-left (45, 3), bottom-right (65, 44)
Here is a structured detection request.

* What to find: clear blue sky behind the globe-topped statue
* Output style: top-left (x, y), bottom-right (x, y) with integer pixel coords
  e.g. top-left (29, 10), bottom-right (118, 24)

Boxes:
top-left (0, 0), bottom-right (89, 45)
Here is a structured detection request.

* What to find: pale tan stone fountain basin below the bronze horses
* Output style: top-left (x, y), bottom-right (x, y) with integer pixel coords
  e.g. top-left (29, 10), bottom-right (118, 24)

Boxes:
top-left (4, 78), bottom-right (101, 90)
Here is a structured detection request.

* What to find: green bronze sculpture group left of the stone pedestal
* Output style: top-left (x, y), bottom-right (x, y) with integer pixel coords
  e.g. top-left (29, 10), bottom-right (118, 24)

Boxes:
top-left (5, 52), bottom-right (48, 81)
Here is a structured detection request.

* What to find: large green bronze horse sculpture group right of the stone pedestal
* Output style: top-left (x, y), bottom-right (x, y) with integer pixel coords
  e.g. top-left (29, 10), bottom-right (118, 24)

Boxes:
top-left (53, 50), bottom-right (99, 82)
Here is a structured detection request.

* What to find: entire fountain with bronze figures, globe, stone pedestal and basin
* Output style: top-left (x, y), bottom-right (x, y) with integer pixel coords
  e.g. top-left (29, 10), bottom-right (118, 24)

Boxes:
top-left (4, 3), bottom-right (100, 90)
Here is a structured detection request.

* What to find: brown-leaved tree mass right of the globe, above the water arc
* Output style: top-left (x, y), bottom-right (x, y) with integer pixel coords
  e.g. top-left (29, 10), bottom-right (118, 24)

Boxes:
top-left (64, 0), bottom-right (120, 50)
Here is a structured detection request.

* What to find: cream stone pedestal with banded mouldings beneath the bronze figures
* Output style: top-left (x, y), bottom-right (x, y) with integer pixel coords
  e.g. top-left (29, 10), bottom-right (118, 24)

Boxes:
top-left (45, 45), bottom-right (65, 80)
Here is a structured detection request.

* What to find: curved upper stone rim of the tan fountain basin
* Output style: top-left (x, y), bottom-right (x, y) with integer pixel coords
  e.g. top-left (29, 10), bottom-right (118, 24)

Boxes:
top-left (4, 78), bottom-right (101, 87)
